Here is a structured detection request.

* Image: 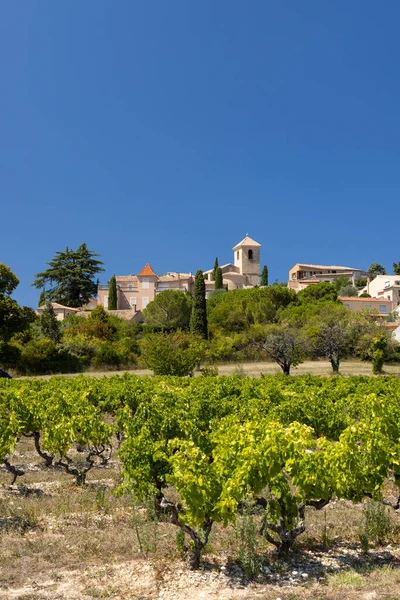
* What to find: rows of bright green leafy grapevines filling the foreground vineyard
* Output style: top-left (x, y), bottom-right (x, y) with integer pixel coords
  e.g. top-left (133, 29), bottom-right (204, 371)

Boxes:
top-left (0, 375), bottom-right (400, 598)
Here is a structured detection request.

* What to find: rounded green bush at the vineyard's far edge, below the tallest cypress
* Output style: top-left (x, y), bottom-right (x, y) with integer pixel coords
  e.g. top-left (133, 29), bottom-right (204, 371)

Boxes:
top-left (141, 331), bottom-right (204, 377)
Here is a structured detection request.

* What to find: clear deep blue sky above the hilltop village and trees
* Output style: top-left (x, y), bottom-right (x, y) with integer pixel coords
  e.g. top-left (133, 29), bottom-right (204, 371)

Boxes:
top-left (0, 0), bottom-right (400, 306)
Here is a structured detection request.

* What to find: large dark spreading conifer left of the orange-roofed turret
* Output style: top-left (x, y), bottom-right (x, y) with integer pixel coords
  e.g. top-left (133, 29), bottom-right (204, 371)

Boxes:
top-left (32, 244), bottom-right (104, 308)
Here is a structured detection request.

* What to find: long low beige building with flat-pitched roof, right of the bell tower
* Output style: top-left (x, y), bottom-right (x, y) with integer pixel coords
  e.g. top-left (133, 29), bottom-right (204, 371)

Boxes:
top-left (288, 263), bottom-right (369, 292)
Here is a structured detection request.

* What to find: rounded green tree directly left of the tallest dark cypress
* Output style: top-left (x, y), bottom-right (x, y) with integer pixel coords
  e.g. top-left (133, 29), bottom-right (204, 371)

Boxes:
top-left (142, 290), bottom-right (192, 329)
